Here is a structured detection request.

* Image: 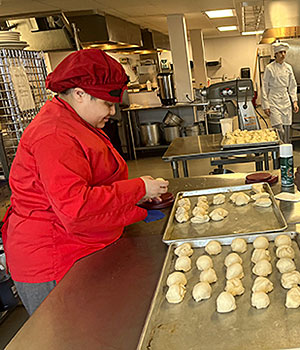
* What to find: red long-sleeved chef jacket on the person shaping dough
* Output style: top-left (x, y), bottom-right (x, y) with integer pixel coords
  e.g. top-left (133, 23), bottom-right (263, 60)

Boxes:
top-left (2, 97), bottom-right (147, 283)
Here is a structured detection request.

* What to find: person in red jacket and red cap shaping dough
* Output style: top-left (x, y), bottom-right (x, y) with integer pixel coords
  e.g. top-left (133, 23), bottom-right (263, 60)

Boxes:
top-left (2, 49), bottom-right (168, 314)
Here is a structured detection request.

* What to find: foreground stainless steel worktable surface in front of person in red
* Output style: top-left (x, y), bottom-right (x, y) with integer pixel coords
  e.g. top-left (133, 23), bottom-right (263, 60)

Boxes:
top-left (3, 173), bottom-right (300, 350)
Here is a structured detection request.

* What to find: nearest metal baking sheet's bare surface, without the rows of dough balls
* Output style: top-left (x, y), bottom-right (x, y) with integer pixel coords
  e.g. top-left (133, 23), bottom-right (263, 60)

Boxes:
top-left (137, 232), bottom-right (300, 350)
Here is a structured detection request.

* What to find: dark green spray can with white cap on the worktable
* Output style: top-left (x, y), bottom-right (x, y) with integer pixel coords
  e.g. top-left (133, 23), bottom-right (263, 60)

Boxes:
top-left (279, 143), bottom-right (294, 187)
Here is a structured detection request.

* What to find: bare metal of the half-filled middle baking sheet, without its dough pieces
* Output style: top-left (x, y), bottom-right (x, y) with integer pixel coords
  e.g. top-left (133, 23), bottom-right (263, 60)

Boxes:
top-left (163, 183), bottom-right (287, 244)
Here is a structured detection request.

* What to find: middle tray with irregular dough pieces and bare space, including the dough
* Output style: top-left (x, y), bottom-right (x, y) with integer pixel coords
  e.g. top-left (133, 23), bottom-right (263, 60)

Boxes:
top-left (163, 183), bottom-right (287, 244)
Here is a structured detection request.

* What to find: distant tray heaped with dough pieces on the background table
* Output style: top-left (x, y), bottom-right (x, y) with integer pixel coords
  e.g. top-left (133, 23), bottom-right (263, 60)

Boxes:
top-left (221, 129), bottom-right (280, 149)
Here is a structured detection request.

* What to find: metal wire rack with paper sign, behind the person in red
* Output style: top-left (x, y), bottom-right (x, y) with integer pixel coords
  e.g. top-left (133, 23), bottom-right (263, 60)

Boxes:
top-left (0, 49), bottom-right (50, 179)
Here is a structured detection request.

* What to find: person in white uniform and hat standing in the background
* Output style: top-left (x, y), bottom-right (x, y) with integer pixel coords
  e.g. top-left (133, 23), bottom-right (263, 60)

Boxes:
top-left (262, 42), bottom-right (299, 143)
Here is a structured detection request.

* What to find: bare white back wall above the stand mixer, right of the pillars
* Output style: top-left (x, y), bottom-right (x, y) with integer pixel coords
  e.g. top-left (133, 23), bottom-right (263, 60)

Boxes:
top-left (204, 35), bottom-right (258, 83)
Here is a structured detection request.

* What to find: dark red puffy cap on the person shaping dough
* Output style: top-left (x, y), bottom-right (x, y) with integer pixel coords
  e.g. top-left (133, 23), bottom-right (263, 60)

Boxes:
top-left (46, 49), bottom-right (128, 102)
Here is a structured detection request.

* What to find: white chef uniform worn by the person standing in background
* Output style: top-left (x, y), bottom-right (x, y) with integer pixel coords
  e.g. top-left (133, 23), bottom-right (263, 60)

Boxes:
top-left (262, 61), bottom-right (297, 126)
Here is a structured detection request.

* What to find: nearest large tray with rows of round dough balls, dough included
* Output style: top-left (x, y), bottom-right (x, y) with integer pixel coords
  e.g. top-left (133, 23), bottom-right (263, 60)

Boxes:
top-left (138, 232), bottom-right (300, 350)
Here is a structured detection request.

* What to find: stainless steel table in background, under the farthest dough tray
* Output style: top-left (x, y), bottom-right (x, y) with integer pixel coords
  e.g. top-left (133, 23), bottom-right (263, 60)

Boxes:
top-left (162, 134), bottom-right (279, 178)
